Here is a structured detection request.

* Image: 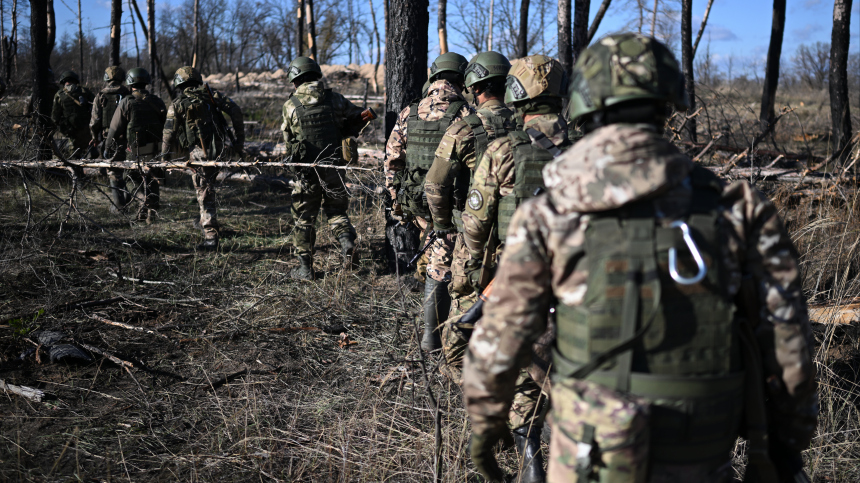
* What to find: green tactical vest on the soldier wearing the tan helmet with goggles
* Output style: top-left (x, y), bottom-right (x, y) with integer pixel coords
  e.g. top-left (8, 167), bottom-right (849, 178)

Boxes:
top-left (497, 128), bottom-right (570, 243)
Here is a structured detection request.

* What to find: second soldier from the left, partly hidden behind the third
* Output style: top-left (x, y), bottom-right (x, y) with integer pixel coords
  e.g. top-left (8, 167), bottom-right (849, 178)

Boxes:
top-left (90, 65), bottom-right (131, 211)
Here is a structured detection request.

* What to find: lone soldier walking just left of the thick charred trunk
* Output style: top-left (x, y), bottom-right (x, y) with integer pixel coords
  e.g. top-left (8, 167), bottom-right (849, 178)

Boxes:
top-left (281, 57), bottom-right (376, 280)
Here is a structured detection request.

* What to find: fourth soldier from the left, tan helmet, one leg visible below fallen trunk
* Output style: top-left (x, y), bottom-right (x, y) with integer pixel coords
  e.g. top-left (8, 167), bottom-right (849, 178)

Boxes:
top-left (161, 65), bottom-right (245, 250)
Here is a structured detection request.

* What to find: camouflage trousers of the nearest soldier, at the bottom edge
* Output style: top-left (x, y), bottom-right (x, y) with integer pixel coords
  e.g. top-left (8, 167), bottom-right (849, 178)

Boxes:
top-left (547, 379), bottom-right (732, 483)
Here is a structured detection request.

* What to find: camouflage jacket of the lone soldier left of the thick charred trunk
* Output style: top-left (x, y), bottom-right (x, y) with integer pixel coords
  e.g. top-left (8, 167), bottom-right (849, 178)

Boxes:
top-left (281, 81), bottom-right (367, 145)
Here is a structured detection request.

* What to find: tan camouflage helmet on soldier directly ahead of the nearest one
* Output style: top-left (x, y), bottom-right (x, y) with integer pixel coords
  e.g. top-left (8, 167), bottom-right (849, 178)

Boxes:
top-left (505, 55), bottom-right (567, 104)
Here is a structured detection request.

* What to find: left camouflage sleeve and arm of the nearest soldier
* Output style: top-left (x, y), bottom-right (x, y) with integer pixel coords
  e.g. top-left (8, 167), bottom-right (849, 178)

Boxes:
top-left (463, 200), bottom-right (552, 434)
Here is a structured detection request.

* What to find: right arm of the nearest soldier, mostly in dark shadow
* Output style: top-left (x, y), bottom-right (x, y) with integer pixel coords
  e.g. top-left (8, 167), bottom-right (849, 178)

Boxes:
top-left (724, 183), bottom-right (818, 451)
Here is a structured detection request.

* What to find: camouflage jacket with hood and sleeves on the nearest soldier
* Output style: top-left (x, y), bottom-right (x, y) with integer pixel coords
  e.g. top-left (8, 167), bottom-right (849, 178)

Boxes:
top-left (463, 124), bottom-right (817, 450)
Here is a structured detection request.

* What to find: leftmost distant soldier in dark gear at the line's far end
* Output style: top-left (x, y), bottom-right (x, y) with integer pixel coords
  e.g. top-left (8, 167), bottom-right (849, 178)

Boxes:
top-left (51, 70), bottom-right (95, 158)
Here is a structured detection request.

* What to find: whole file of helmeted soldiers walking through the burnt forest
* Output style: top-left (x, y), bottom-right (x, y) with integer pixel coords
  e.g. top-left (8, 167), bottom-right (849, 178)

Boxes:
top-left (42, 34), bottom-right (818, 483)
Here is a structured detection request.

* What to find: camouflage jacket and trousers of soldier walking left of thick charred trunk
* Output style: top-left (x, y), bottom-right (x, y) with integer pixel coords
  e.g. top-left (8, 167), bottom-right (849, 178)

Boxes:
top-left (281, 81), bottom-right (367, 255)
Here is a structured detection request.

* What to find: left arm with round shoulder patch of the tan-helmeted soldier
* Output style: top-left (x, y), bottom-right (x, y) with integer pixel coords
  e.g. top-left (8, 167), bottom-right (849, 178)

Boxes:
top-left (463, 139), bottom-right (513, 258)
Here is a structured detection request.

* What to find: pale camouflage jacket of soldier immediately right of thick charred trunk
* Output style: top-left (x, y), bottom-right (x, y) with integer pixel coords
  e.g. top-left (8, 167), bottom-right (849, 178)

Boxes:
top-left (384, 79), bottom-right (475, 196)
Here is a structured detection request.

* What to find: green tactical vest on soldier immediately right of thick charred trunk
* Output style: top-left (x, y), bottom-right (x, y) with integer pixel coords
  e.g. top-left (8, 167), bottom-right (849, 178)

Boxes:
top-left (394, 101), bottom-right (466, 217)
